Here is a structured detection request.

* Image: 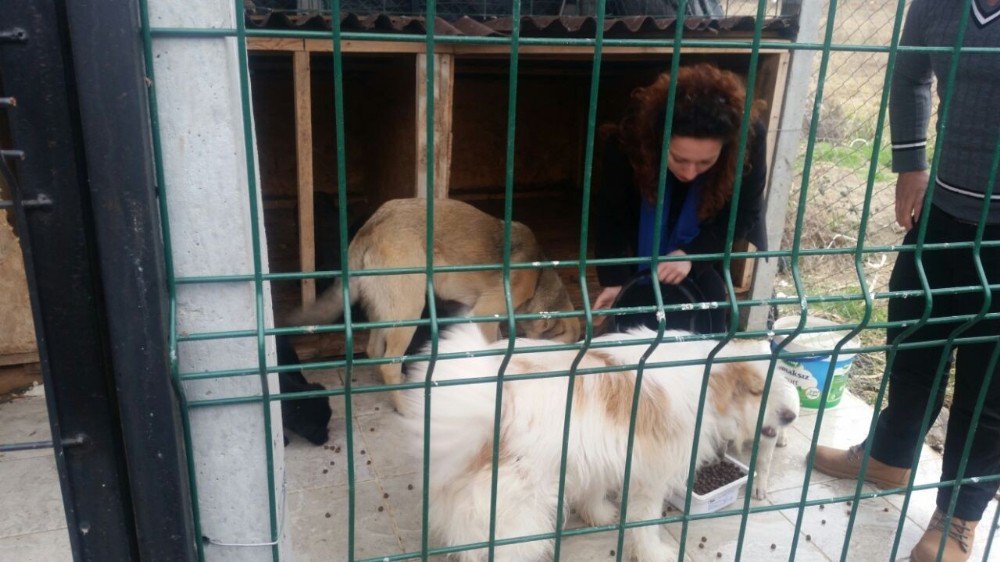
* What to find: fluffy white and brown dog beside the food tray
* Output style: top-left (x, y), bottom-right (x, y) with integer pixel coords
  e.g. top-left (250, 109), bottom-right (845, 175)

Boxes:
top-left (405, 326), bottom-right (797, 561)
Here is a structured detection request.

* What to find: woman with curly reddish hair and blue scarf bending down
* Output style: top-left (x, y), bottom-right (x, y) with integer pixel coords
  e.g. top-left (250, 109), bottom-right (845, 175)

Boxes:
top-left (593, 64), bottom-right (767, 331)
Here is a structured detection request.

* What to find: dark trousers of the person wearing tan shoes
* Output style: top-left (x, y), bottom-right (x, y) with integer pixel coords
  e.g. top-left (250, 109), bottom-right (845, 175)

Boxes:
top-left (872, 203), bottom-right (1000, 521)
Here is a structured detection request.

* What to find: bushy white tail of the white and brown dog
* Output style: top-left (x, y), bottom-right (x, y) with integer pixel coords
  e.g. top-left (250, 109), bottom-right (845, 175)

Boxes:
top-left (402, 324), bottom-right (506, 482)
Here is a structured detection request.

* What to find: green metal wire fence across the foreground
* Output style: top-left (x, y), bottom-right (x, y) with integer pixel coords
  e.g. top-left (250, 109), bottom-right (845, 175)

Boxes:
top-left (141, 0), bottom-right (1000, 561)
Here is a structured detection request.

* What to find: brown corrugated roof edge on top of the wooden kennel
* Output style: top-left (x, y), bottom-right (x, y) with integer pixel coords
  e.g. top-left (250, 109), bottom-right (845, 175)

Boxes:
top-left (246, 12), bottom-right (798, 39)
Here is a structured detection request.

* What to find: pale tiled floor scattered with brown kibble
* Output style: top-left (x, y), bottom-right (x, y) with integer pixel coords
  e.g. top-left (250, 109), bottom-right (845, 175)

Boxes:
top-left (0, 371), bottom-right (1000, 562)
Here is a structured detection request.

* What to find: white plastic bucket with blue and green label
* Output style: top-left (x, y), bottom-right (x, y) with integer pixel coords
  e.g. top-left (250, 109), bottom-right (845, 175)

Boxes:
top-left (771, 316), bottom-right (857, 409)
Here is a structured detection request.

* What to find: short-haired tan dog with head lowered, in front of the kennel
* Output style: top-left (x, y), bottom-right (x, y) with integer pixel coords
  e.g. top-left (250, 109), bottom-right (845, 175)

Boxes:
top-left (291, 199), bottom-right (580, 409)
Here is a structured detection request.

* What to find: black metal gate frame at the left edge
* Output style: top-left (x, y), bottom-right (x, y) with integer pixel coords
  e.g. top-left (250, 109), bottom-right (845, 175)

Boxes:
top-left (0, 0), bottom-right (195, 561)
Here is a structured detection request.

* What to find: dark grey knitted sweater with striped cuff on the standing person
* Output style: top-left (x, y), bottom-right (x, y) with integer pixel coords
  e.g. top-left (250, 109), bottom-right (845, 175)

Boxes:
top-left (889, 0), bottom-right (1000, 224)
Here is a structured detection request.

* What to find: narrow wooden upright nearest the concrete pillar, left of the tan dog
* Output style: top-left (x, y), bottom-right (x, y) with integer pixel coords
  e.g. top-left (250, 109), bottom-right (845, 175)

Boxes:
top-left (292, 51), bottom-right (316, 305)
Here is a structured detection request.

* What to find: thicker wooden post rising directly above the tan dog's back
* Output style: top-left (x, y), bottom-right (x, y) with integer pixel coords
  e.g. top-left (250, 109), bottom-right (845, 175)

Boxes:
top-left (416, 54), bottom-right (455, 199)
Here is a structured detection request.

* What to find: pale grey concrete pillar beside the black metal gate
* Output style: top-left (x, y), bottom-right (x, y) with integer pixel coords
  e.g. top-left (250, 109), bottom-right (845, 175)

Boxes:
top-left (149, 0), bottom-right (284, 561)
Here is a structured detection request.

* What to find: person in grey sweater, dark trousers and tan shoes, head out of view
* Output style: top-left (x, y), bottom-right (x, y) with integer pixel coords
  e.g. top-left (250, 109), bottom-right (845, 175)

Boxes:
top-left (815, 0), bottom-right (1000, 562)
